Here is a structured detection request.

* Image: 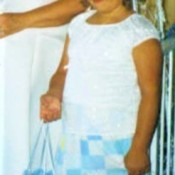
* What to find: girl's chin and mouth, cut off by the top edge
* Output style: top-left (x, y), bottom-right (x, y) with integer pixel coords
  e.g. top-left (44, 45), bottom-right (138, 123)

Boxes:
top-left (89, 0), bottom-right (122, 12)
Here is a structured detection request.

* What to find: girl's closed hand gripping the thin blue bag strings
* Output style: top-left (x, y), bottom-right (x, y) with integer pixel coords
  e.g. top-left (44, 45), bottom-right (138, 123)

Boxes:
top-left (40, 94), bottom-right (61, 122)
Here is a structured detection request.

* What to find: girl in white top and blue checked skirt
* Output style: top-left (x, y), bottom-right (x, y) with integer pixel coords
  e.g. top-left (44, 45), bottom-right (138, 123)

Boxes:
top-left (41, 0), bottom-right (162, 175)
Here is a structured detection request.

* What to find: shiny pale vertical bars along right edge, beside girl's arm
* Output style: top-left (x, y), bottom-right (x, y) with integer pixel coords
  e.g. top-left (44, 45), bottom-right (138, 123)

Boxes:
top-left (153, 47), bottom-right (175, 175)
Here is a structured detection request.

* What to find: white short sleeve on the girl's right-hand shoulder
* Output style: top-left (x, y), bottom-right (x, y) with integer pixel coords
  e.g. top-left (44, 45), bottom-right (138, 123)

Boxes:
top-left (132, 15), bottom-right (160, 47)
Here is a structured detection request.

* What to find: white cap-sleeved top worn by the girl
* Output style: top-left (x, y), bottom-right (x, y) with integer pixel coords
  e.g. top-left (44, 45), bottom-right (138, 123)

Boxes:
top-left (63, 11), bottom-right (159, 137)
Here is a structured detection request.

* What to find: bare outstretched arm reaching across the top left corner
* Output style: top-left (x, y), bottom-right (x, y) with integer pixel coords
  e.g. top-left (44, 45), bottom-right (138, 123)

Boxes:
top-left (0, 0), bottom-right (86, 38)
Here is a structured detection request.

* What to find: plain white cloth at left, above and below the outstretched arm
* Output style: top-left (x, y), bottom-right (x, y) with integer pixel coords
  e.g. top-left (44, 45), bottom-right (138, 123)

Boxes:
top-left (0, 0), bottom-right (66, 175)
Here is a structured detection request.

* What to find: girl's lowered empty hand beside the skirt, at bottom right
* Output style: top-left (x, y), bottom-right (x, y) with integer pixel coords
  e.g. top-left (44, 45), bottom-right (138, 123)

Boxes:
top-left (124, 148), bottom-right (150, 175)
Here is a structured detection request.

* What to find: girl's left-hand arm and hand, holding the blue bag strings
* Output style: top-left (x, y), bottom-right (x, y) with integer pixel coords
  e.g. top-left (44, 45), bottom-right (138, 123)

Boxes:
top-left (40, 37), bottom-right (69, 122)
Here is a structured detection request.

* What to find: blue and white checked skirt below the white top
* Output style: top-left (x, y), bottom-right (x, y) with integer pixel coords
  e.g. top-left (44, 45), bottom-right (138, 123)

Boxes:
top-left (56, 134), bottom-right (132, 175)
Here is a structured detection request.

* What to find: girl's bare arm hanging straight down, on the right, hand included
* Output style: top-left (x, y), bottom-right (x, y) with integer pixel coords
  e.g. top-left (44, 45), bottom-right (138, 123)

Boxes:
top-left (125, 39), bottom-right (162, 175)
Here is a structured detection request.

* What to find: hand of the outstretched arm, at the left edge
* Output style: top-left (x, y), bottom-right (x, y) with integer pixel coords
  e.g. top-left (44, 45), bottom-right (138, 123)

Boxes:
top-left (0, 13), bottom-right (25, 38)
